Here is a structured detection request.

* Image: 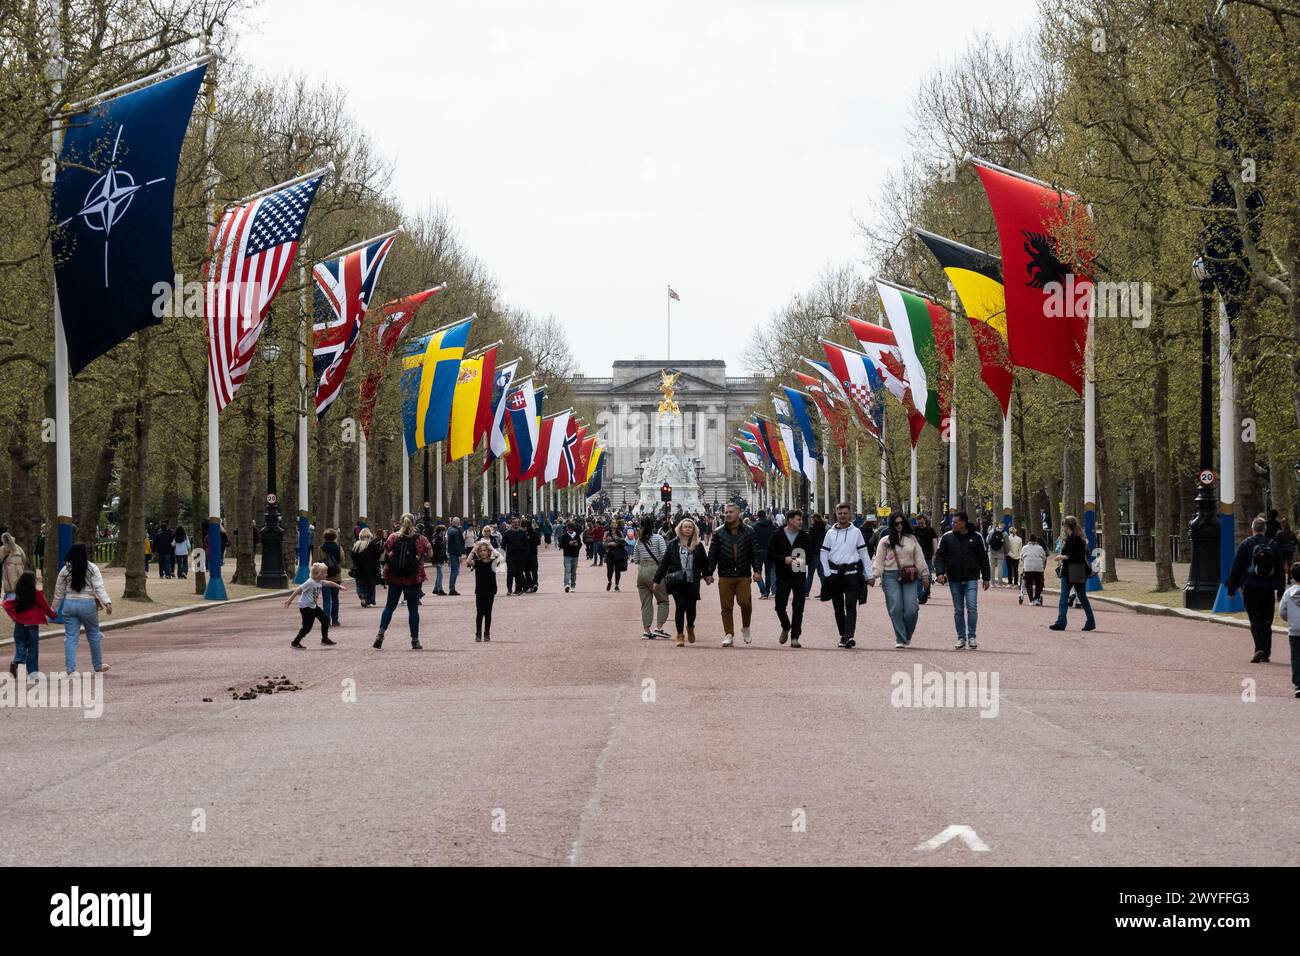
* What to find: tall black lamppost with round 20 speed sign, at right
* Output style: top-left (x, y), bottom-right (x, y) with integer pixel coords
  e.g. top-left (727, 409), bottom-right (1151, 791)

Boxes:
top-left (1190, 256), bottom-right (1219, 611)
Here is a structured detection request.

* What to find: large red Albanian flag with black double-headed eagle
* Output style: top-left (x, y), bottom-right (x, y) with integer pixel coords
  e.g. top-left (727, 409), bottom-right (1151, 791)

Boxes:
top-left (972, 160), bottom-right (1093, 395)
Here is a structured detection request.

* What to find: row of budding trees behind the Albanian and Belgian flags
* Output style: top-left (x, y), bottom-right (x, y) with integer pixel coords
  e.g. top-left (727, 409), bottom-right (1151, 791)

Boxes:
top-left (750, 0), bottom-right (1300, 589)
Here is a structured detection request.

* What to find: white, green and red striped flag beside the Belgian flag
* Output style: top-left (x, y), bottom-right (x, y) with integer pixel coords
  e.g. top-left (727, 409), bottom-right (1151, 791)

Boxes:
top-left (876, 280), bottom-right (953, 429)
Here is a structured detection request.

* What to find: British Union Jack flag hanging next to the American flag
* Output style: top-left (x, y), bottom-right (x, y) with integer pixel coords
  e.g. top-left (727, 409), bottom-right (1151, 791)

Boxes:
top-left (312, 235), bottom-right (395, 419)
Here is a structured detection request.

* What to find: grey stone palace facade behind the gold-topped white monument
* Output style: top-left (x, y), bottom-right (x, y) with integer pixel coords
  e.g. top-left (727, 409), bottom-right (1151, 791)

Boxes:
top-left (572, 359), bottom-right (762, 506)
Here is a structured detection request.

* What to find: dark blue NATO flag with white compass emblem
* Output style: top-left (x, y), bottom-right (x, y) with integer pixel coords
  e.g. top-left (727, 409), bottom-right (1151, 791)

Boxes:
top-left (51, 66), bottom-right (207, 375)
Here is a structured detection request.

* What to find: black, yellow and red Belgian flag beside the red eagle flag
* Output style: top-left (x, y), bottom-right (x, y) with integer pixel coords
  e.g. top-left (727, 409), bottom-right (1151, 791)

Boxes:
top-left (913, 229), bottom-right (1014, 418)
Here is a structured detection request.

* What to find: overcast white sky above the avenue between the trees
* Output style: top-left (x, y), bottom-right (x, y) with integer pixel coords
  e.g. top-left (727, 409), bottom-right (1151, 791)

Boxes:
top-left (238, 0), bottom-right (1034, 375)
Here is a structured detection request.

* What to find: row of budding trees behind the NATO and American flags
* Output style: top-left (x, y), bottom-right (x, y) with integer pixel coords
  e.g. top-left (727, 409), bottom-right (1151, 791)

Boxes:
top-left (0, 0), bottom-right (573, 598)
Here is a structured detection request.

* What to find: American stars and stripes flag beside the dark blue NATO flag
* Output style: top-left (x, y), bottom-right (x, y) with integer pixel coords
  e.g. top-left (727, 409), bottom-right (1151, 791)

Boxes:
top-left (205, 176), bottom-right (322, 411)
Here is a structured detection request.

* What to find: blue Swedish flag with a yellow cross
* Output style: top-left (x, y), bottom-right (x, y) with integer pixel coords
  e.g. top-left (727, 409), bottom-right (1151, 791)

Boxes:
top-left (402, 319), bottom-right (471, 451)
